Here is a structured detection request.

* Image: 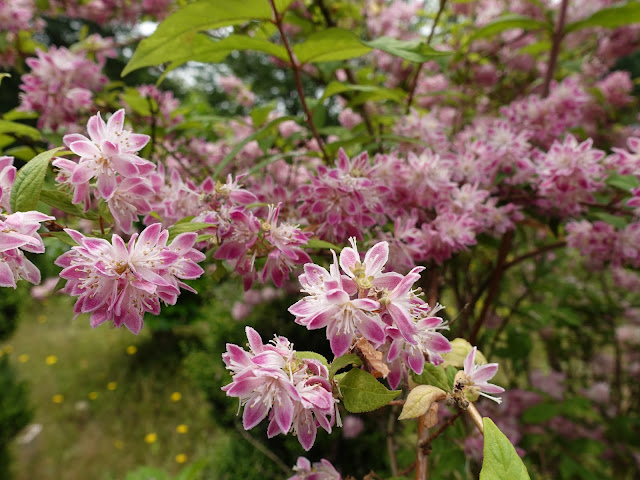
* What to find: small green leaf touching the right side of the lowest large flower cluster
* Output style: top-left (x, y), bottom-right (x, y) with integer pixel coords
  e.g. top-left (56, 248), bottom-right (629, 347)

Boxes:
top-left (340, 368), bottom-right (402, 413)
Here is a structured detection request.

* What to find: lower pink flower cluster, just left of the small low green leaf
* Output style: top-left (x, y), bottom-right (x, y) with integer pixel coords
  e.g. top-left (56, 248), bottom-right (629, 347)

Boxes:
top-left (222, 327), bottom-right (335, 450)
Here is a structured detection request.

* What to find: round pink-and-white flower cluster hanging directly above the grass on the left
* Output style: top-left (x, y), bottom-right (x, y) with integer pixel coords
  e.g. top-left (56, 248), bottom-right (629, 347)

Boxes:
top-left (55, 223), bottom-right (204, 334)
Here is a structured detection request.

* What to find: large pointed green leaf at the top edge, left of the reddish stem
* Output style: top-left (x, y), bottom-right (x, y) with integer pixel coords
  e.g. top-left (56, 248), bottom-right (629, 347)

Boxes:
top-left (122, 0), bottom-right (273, 76)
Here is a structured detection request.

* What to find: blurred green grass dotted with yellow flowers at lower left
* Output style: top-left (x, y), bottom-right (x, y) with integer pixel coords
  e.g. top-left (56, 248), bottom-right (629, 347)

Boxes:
top-left (0, 298), bottom-right (215, 480)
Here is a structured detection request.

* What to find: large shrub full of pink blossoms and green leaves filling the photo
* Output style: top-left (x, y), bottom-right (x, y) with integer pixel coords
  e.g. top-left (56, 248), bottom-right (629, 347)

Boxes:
top-left (0, 0), bottom-right (640, 480)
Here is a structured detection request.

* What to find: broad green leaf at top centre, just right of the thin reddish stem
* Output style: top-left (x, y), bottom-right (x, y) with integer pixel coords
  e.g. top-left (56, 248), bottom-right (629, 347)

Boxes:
top-left (293, 28), bottom-right (371, 64)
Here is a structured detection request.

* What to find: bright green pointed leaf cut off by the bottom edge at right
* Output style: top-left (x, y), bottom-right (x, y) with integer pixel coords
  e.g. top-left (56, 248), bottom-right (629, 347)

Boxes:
top-left (480, 417), bottom-right (531, 480)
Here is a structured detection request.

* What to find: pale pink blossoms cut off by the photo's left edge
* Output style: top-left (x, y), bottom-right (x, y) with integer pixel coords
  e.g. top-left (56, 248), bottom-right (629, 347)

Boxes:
top-left (0, 212), bottom-right (55, 288)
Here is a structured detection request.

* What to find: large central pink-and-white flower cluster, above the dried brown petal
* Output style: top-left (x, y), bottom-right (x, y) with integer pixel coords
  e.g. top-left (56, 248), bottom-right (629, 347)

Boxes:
top-left (289, 238), bottom-right (451, 388)
